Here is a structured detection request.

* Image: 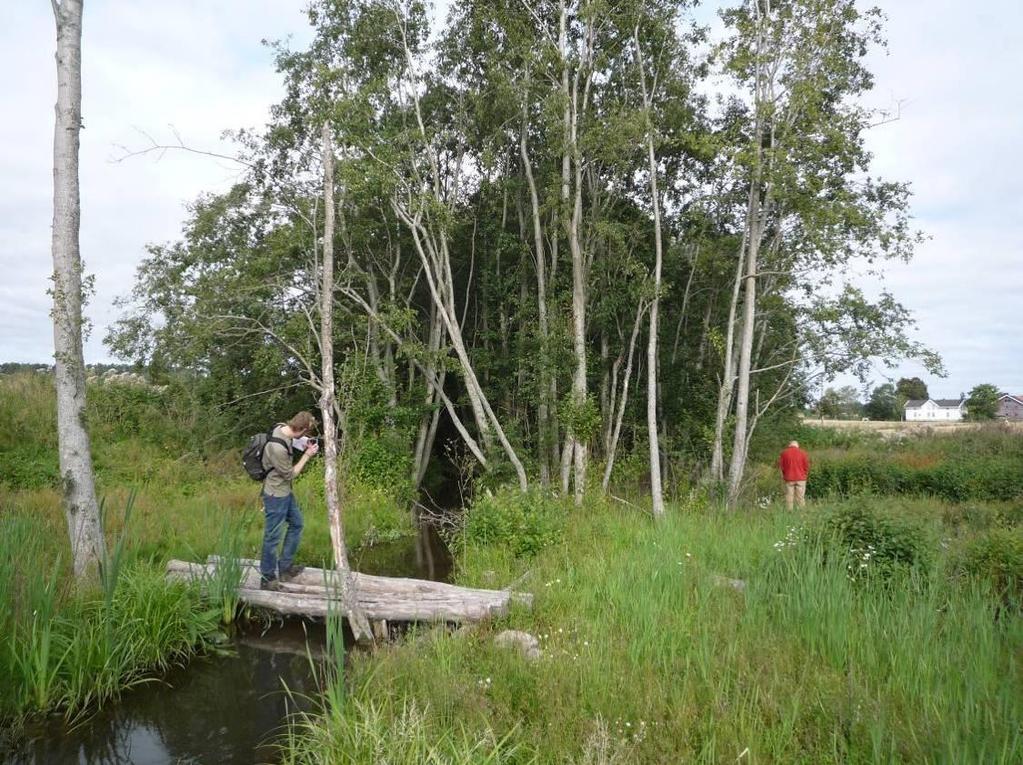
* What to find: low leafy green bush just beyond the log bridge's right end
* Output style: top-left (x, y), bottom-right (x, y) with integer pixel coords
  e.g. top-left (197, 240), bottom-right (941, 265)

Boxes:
top-left (462, 488), bottom-right (568, 556)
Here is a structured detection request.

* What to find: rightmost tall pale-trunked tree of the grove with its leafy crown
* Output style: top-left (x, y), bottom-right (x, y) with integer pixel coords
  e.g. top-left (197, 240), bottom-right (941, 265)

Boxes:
top-left (723, 0), bottom-right (937, 504)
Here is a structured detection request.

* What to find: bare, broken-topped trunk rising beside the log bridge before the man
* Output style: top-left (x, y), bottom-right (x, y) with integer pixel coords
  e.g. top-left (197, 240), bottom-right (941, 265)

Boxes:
top-left (319, 123), bottom-right (372, 642)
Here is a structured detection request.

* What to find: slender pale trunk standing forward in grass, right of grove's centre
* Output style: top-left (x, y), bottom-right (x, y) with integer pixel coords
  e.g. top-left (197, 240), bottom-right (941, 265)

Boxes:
top-left (633, 27), bottom-right (664, 519)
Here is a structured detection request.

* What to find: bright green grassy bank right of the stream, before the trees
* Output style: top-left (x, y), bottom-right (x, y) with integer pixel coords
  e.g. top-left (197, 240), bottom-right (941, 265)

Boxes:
top-left (288, 492), bottom-right (1023, 763)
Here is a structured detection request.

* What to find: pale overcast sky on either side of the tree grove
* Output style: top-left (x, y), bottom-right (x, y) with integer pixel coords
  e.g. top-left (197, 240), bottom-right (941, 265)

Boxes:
top-left (0, 0), bottom-right (1023, 397)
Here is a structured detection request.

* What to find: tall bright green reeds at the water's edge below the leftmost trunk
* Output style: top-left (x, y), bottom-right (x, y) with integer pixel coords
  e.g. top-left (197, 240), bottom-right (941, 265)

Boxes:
top-left (0, 516), bottom-right (217, 724)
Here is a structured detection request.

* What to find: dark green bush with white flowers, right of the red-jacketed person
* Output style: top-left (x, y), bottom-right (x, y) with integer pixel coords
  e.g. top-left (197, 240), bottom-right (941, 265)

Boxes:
top-left (820, 500), bottom-right (931, 577)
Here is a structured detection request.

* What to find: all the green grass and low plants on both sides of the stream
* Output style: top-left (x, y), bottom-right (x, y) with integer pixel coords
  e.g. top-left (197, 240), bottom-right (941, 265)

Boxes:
top-left (0, 368), bottom-right (1023, 764)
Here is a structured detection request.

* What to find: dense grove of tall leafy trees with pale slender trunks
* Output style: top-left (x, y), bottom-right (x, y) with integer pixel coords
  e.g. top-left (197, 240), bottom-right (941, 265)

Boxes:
top-left (107, 0), bottom-right (940, 499)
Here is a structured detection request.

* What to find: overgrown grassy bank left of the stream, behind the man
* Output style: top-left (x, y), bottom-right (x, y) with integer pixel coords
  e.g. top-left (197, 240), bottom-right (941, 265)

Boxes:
top-left (0, 374), bottom-right (410, 743)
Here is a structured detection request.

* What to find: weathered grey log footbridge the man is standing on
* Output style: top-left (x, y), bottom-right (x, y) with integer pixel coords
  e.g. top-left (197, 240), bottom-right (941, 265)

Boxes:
top-left (167, 555), bottom-right (533, 636)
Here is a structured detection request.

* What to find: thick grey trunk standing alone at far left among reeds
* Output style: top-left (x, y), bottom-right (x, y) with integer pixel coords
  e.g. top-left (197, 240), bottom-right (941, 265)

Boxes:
top-left (52, 0), bottom-right (105, 579)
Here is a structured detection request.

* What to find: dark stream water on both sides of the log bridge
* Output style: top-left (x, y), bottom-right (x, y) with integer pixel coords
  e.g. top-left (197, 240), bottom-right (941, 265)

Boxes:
top-left (0, 527), bottom-right (451, 765)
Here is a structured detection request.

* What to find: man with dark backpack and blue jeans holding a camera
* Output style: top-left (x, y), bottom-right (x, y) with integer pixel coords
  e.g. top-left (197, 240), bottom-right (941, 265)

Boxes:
top-left (259, 412), bottom-right (319, 591)
